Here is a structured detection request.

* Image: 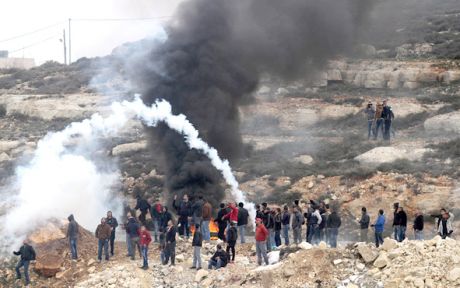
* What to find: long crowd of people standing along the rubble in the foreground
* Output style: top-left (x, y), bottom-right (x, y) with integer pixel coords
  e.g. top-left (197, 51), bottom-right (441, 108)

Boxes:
top-left (14, 195), bottom-right (454, 284)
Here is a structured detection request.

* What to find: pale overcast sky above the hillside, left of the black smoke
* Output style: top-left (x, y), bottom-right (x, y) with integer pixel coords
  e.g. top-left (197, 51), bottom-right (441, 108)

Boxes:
top-left (0, 0), bottom-right (182, 64)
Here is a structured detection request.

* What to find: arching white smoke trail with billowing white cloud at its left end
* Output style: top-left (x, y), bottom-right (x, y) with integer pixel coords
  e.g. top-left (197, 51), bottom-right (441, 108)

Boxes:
top-left (0, 97), bottom-right (255, 251)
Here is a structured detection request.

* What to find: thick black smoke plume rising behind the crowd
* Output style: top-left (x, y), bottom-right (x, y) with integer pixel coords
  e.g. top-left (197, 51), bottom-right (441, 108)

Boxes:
top-left (134, 0), bottom-right (371, 207)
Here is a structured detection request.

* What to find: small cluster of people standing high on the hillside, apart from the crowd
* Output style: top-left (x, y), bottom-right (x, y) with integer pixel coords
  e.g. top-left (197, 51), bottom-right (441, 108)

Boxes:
top-left (364, 100), bottom-right (395, 141)
